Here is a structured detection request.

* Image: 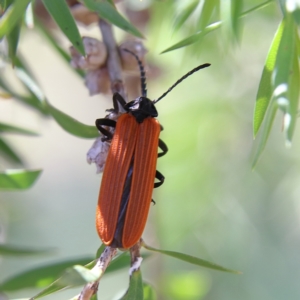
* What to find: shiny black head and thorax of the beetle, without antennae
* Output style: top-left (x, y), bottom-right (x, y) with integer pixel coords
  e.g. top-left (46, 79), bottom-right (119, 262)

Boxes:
top-left (124, 97), bottom-right (158, 123)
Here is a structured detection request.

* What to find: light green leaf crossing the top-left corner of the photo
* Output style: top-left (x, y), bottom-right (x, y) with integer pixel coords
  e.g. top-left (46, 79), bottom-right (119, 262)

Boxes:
top-left (0, 0), bottom-right (31, 39)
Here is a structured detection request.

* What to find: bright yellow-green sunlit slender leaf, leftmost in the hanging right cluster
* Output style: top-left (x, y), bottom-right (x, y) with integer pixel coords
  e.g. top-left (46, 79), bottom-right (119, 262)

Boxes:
top-left (253, 21), bottom-right (284, 137)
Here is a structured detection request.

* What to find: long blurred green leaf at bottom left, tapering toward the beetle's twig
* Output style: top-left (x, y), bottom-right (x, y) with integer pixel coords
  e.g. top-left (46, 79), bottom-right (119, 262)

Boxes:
top-left (0, 257), bottom-right (93, 291)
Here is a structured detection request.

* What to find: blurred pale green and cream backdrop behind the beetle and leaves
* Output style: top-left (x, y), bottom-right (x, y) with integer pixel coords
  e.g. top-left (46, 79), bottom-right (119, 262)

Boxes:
top-left (0, 0), bottom-right (300, 300)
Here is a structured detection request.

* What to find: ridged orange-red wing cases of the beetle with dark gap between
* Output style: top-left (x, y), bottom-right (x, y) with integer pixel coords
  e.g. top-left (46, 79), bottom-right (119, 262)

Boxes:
top-left (96, 114), bottom-right (160, 248)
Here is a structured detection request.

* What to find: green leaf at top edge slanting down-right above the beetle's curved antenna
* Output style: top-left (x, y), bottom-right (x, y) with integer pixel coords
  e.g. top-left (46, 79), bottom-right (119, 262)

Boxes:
top-left (83, 0), bottom-right (143, 38)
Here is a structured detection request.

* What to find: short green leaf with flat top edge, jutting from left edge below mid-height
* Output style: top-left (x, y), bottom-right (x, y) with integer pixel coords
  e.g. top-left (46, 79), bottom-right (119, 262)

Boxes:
top-left (0, 169), bottom-right (42, 190)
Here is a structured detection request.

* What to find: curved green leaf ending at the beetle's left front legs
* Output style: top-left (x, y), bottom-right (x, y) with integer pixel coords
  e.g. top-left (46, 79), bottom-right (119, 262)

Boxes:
top-left (47, 103), bottom-right (99, 139)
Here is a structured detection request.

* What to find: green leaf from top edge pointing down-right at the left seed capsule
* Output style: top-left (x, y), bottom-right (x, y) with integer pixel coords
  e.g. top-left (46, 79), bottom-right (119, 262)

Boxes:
top-left (42, 0), bottom-right (85, 55)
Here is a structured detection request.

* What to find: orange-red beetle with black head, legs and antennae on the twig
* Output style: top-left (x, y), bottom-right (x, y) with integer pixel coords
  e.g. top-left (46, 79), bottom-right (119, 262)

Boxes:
top-left (96, 49), bottom-right (210, 249)
